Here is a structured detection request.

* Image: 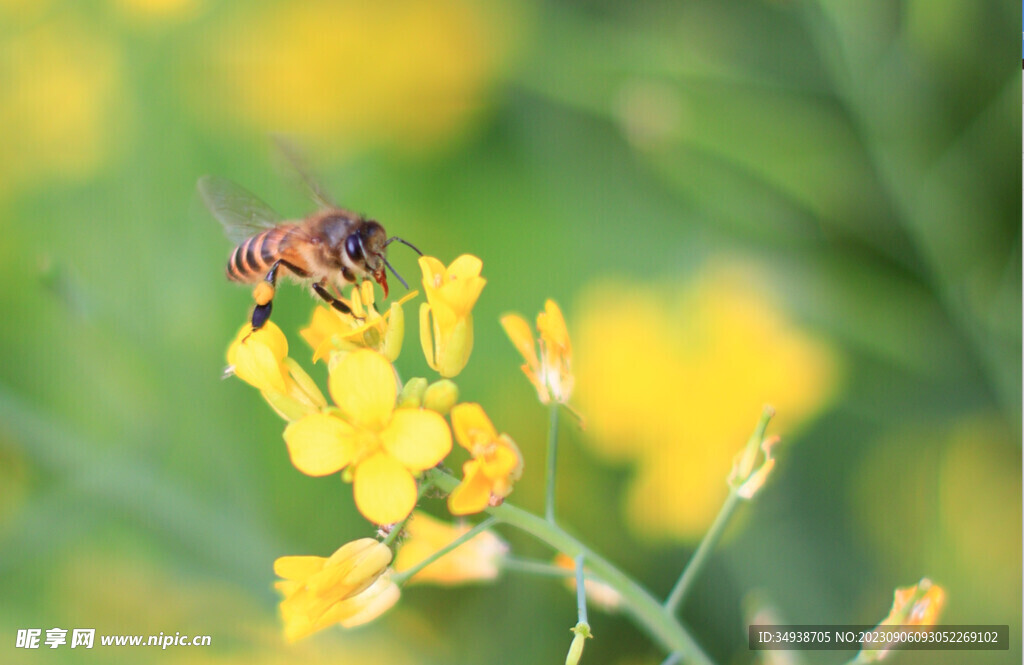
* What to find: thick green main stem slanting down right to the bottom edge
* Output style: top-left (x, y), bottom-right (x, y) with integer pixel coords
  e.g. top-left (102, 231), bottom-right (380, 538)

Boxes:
top-left (427, 469), bottom-right (713, 665)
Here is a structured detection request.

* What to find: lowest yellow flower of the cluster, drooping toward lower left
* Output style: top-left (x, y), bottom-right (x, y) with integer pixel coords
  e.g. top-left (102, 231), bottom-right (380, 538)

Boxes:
top-left (273, 538), bottom-right (399, 641)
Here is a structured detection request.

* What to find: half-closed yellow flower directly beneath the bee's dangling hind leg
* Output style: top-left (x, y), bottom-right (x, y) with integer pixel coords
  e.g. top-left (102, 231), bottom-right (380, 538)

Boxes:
top-left (227, 321), bottom-right (327, 420)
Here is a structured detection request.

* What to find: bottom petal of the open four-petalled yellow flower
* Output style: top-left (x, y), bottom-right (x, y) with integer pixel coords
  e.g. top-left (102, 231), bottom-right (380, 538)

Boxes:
top-left (352, 453), bottom-right (416, 525)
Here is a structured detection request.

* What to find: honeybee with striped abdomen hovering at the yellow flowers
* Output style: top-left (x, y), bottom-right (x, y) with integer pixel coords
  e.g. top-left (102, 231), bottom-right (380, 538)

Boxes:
top-left (197, 171), bottom-right (422, 331)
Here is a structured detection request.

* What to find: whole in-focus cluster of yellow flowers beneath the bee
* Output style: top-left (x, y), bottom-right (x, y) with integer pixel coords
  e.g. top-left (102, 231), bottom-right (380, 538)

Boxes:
top-left (227, 255), bottom-right (540, 640)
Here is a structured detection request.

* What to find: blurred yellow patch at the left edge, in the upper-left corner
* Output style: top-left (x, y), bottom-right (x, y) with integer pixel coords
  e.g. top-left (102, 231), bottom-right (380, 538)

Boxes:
top-left (0, 16), bottom-right (129, 196)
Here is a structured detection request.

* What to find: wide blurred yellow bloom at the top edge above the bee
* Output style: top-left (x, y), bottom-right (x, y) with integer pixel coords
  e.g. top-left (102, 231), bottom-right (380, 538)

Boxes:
top-left (187, 0), bottom-right (520, 152)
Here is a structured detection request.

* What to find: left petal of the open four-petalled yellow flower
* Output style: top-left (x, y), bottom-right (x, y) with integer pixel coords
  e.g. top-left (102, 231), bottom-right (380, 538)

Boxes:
top-left (285, 413), bottom-right (354, 475)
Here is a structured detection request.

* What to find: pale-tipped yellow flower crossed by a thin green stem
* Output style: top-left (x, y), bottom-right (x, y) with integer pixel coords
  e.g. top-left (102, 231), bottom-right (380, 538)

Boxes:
top-left (394, 510), bottom-right (508, 584)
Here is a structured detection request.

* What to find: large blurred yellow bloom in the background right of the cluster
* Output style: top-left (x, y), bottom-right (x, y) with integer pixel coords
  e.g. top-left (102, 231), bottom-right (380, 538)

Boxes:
top-left (573, 263), bottom-right (838, 540)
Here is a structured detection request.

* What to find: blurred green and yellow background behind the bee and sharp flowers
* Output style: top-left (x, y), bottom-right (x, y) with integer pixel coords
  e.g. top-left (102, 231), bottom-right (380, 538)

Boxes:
top-left (0, 0), bottom-right (1021, 664)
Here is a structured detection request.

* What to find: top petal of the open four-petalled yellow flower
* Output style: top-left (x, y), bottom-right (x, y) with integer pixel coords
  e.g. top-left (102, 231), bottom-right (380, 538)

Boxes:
top-left (328, 348), bottom-right (398, 430)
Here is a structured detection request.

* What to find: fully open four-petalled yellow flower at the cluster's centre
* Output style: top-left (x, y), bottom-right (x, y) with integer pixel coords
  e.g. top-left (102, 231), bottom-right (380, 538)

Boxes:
top-left (285, 348), bottom-right (452, 525)
